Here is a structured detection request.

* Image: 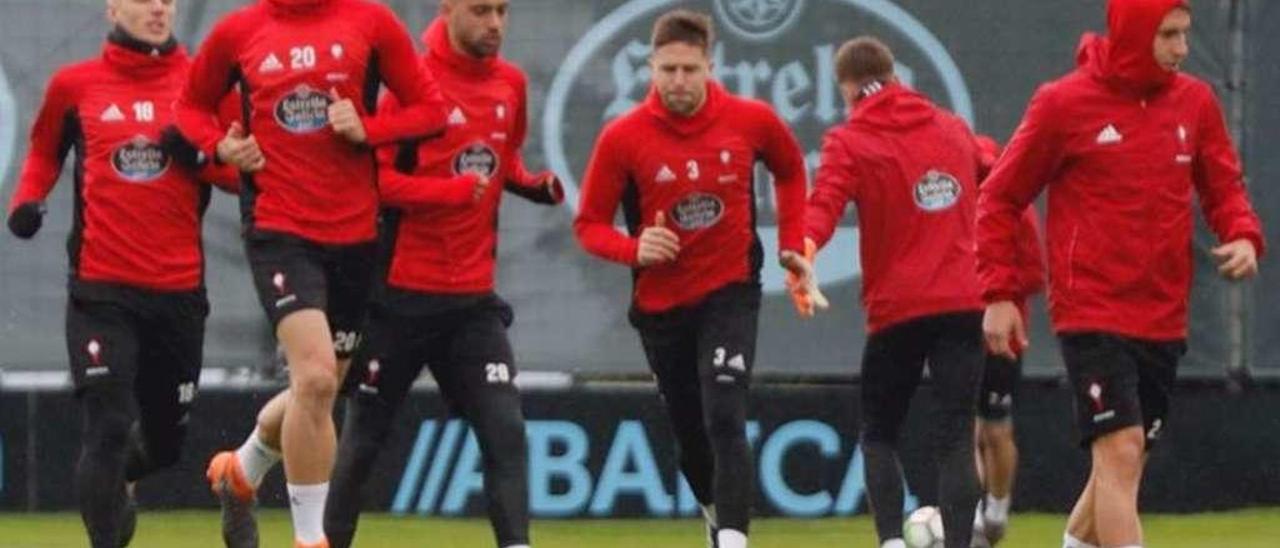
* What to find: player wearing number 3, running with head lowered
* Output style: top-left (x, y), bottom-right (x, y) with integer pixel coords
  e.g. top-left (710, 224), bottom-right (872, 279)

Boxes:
top-left (573, 10), bottom-right (813, 548)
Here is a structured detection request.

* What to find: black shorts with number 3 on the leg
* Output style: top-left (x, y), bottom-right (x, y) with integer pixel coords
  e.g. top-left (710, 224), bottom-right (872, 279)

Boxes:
top-left (630, 283), bottom-right (760, 389)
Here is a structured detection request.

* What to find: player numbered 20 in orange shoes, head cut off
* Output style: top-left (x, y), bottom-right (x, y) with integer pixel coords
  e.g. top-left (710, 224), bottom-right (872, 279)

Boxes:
top-left (175, 0), bottom-right (444, 547)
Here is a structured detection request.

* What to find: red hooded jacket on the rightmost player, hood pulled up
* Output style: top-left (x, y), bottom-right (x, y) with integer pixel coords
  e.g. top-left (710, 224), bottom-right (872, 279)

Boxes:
top-left (978, 0), bottom-right (1263, 341)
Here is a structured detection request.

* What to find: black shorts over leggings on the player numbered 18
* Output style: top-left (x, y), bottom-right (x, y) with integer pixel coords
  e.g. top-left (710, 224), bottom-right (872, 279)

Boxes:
top-left (67, 284), bottom-right (209, 423)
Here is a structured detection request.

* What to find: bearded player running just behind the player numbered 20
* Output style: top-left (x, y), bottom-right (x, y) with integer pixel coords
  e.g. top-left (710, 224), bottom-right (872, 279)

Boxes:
top-left (325, 0), bottom-right (563, 548)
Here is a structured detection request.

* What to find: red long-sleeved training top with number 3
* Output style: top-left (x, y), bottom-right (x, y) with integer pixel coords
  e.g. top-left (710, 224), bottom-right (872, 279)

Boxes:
top-left (573, 82), bottom-right (806, 312)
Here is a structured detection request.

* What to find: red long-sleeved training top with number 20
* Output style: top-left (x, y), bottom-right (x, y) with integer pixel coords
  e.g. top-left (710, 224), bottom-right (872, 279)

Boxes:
top-left (177, 0), bottom-right (444, 245)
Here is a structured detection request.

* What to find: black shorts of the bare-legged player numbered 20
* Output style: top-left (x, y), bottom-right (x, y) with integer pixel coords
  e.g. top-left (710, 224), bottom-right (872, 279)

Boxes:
top-left (244, 232), bottom-right (378, 359)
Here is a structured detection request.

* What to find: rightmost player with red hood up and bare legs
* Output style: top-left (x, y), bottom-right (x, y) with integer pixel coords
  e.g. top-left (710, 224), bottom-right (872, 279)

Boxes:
top-left (978, 0), bottom-right (1263, 547)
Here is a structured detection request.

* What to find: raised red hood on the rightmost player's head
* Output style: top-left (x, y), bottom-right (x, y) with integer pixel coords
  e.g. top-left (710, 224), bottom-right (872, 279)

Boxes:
top-left (1076, 0), bottom-right (1189, 95)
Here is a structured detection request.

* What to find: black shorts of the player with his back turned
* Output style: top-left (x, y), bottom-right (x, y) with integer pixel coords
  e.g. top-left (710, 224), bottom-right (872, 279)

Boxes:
top-left (861, 311), bottom-right (984, 442)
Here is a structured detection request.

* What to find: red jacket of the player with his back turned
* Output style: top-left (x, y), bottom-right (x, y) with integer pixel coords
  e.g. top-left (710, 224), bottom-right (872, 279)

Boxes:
top-left (805, 85), bottom-right (982, 333)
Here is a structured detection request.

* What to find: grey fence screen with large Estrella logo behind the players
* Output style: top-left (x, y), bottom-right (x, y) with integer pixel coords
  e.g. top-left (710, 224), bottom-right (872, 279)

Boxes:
top-left (0, 0), bottom-right (1280, 376)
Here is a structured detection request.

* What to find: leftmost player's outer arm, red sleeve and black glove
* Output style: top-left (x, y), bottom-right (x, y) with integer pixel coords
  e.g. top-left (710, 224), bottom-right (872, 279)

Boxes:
top-left (8, 72), bottom-right (77, 238)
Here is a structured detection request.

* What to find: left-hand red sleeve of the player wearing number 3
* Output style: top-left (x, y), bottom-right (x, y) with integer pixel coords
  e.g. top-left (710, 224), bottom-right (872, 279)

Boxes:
top-left (573, 127), bottom-right (640, 266)
